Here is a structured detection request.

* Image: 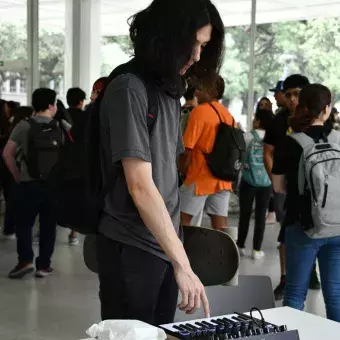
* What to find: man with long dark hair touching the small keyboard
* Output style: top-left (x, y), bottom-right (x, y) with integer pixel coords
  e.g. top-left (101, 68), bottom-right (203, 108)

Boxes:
top-left (97, 0), bottom-right (224, 325)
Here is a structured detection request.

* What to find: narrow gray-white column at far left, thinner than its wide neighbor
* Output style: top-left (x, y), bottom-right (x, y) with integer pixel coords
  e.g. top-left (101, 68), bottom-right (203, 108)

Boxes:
top-left (27, 0), bottom-right (40, 103)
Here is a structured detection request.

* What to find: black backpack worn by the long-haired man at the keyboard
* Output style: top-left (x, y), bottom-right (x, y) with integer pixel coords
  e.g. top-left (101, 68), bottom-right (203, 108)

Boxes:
top-left (56, 60), bottom-right (158, 235)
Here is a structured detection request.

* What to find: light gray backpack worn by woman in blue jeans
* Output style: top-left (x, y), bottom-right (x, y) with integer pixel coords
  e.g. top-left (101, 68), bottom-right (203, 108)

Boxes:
top-left (290, 130), bottom-right (340, 239)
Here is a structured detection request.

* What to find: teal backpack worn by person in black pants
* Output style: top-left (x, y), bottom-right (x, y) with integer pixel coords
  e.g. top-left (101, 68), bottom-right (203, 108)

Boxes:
top-left (242, 131), bottom-right (271, 187)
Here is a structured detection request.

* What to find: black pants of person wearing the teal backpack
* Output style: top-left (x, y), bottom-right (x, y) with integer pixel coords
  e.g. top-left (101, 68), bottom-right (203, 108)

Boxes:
top-left (237, 180), bottom-right (272, 250)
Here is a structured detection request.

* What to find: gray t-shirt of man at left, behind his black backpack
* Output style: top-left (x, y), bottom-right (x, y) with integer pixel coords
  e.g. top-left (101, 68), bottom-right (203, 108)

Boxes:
top-left (9, 115), bottom-right (52, 182)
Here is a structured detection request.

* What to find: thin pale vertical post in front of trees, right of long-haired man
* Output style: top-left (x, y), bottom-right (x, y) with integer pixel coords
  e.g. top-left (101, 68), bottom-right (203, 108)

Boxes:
top-left (247, 0), bottom-right (256, 131)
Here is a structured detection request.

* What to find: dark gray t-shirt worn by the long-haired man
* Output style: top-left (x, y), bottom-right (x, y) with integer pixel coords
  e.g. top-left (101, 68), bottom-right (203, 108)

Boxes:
top-left (99, 74), bottom-right (184, 260)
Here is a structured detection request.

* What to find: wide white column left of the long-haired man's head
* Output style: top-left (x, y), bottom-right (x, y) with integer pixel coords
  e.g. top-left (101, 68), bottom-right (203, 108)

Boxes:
top-left (65, 0), bottom-right (101, 97)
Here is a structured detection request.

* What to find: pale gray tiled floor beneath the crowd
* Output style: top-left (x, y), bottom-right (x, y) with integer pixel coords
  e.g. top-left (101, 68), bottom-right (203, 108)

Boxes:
top-left (0, 219), bottom-right (325, 340)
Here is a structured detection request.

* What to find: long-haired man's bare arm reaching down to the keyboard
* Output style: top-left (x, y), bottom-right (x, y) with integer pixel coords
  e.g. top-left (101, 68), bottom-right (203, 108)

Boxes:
top-left (122, 158), bottom-right (210, 316)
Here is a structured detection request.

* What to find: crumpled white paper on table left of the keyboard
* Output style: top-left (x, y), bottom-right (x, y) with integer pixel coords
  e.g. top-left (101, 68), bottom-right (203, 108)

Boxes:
top-left (86, 320), bottom-right (167, 340)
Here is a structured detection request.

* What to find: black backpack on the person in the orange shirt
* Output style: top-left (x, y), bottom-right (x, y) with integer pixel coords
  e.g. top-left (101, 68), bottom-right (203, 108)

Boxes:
top-left (206, 104), bottom-right (246, 182)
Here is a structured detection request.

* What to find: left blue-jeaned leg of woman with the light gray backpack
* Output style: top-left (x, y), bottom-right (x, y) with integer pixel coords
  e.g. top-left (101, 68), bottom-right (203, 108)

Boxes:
top-left (283, 224), bottom-right (323, 310)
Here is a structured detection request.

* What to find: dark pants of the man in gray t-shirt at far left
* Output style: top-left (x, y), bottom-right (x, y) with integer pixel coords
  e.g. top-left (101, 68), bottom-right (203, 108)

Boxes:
top-left (16, 181), bottom-right (57, 269)
